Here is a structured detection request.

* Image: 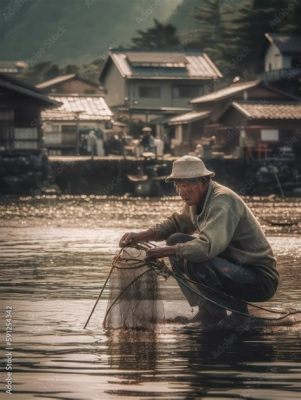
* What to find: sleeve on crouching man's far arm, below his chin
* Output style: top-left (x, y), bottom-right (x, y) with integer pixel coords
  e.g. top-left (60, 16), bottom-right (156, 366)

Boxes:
top-left (151, 206), bottom-right (196, 241)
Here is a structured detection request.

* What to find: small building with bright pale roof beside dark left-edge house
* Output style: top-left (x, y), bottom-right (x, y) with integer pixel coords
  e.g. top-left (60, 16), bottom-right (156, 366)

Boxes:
top-left (42, 94), bottom-right (113, 155)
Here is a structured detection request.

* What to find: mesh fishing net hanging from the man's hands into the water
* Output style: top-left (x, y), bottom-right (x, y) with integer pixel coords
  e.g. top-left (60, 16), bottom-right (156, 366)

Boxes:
top-left (104, 247), bottom-right (164, 329)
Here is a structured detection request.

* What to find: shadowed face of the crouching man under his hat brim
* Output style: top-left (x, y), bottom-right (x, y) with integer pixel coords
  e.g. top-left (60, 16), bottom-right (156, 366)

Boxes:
top-left (175, 179), bottom-right (207, 206)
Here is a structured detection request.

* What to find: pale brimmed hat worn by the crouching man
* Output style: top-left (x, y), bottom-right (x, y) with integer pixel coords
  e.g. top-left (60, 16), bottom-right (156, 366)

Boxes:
top-left (166, 156), bottom-right (215, 182)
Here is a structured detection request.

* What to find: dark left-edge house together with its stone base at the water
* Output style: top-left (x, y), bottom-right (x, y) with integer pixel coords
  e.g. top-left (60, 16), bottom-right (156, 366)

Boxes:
top-left (0, 73), bottom-right (58, 194)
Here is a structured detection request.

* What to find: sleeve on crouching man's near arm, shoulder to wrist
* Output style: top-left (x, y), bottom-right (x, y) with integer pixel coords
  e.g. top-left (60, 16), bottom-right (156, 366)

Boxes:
top-left (176, 199), bottom-right (240, 262)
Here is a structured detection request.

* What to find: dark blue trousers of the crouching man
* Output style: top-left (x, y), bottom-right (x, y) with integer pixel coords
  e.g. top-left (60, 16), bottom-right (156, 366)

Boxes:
top-left (167, 233), bottom-right (272, 311)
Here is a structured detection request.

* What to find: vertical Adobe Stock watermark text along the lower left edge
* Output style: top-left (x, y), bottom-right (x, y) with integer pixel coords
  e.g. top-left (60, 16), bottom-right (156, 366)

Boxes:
top-left (4, 305), bottom-right (14, 395)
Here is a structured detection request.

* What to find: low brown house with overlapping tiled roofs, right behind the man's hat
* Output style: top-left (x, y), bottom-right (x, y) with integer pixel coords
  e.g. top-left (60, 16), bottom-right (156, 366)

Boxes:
top-left (167, 81), bottom-right (301, 158)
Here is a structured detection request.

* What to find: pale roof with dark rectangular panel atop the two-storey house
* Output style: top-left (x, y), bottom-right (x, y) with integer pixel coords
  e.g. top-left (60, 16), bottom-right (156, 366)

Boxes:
top-left (100, 49), bottom-right (222, 80)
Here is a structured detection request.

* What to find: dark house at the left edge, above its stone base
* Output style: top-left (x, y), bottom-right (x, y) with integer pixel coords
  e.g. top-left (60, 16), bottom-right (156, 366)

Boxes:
top-left (0, 74), bottom-right (58, 154)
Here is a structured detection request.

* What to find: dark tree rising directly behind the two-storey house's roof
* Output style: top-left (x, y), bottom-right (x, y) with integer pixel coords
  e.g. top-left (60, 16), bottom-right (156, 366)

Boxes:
top-left (131, 19), bottom-right (180, 49)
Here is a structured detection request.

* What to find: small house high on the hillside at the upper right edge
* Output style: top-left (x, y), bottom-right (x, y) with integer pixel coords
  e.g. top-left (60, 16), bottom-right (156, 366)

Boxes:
top-left (260, 33), bottom-right (301, 97)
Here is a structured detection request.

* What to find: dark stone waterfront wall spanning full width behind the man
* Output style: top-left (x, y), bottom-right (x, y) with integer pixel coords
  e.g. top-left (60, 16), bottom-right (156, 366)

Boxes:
top-left (0, 155), bottom-right (301, 196)
